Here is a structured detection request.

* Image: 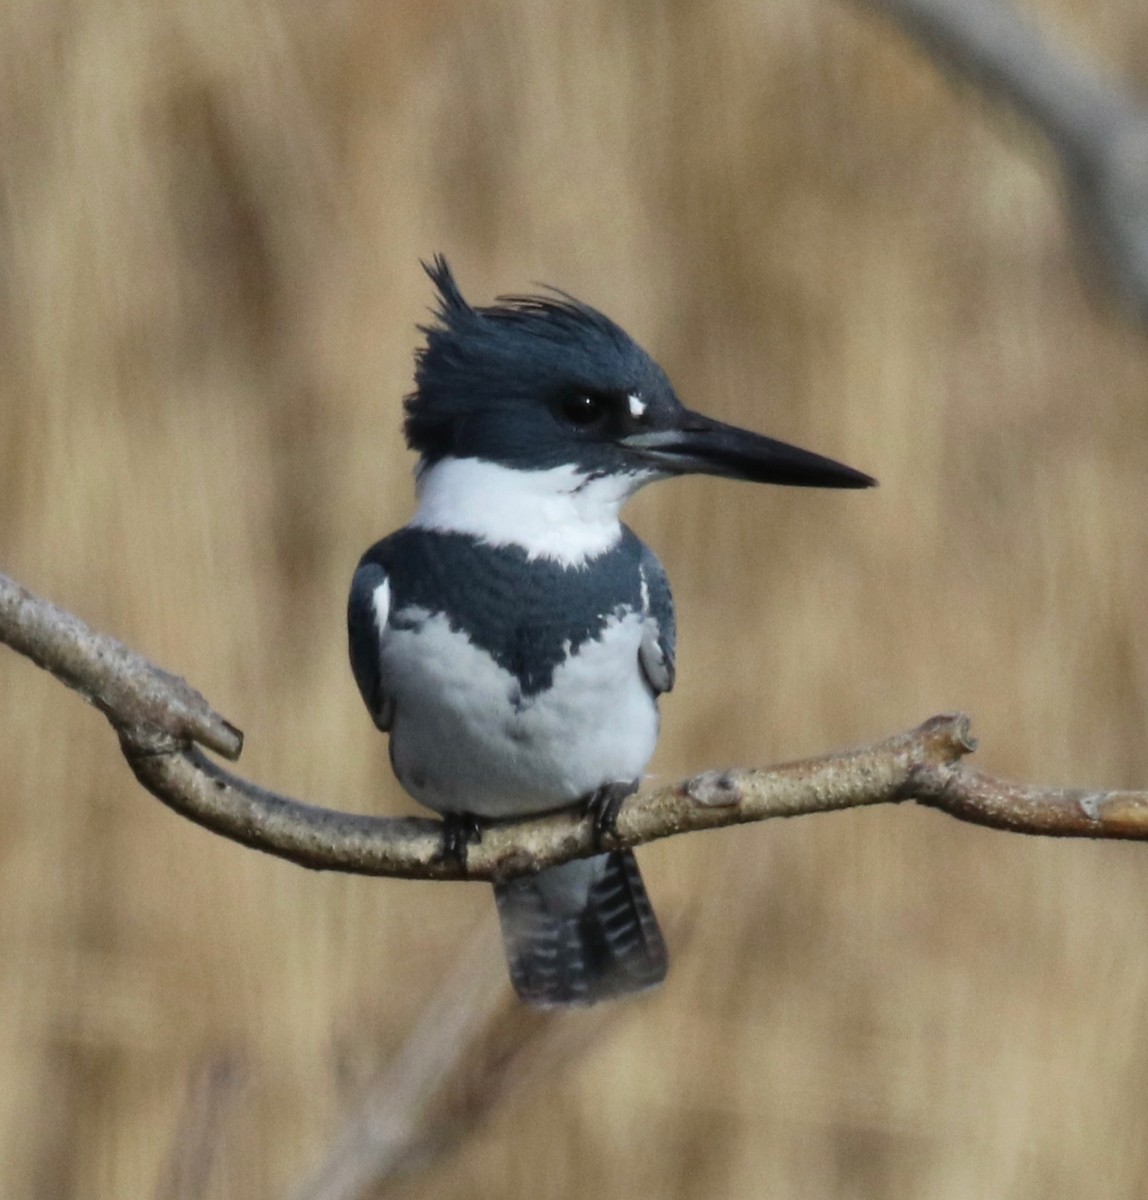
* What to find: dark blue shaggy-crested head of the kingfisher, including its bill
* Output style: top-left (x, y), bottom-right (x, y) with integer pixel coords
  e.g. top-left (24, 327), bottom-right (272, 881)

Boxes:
top-left (405, 256), bottom-right (874, 491)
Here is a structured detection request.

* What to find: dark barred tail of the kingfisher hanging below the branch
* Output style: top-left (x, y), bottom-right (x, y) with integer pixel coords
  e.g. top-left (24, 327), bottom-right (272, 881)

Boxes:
top-left (494, 850), bottom-right (667, 1008)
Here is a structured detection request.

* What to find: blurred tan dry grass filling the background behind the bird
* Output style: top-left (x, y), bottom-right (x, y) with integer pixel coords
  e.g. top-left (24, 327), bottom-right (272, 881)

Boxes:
top-left (0, 0), bottom-right (1148, 1200)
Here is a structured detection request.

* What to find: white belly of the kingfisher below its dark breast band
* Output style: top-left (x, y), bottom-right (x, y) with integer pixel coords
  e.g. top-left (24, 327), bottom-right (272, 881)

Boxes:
top-left (380, 610), bottom-right (657, 817)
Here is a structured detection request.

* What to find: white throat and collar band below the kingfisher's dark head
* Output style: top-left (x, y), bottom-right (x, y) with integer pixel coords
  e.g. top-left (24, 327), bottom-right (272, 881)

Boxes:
top-left (410, 458), bottom-right (657, 566)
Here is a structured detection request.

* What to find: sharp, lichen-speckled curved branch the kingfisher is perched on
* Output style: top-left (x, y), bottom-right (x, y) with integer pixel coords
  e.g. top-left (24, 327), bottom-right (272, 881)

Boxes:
top-left (0, 575), bottom-right (1148, 880)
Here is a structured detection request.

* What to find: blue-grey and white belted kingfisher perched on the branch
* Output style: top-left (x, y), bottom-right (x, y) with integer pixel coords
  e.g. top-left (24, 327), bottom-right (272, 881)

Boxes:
top-left (348, 256), bottom-right (874, 1007)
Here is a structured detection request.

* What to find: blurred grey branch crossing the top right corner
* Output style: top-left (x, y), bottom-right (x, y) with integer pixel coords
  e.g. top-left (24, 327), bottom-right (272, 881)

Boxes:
top-left (867, 0), bottom-right (1148, 322)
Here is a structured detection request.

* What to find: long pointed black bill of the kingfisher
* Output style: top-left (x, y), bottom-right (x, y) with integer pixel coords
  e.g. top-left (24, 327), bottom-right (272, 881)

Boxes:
top-left (621, 409), bottom-right (877, 487)
